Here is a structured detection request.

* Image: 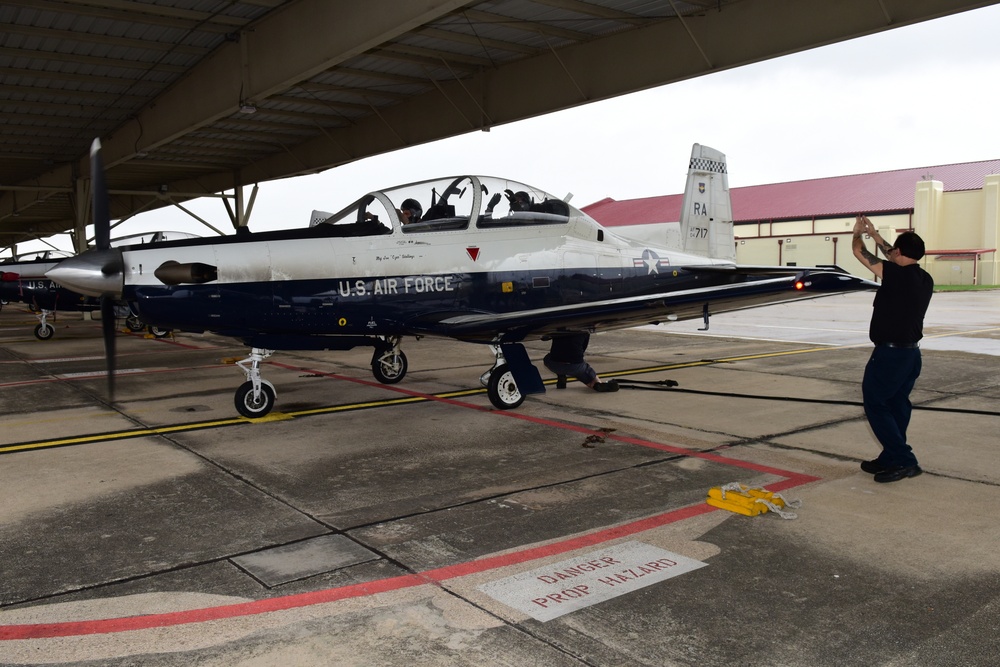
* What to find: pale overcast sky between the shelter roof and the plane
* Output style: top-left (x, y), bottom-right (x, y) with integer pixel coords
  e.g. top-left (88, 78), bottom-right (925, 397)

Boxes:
top-left (19, 5), bottom-right (1000, 250)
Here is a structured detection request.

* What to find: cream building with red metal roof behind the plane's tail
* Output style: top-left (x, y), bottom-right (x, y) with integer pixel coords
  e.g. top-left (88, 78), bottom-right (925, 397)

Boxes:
top-left (583, 160), bottom-right (1000, 284)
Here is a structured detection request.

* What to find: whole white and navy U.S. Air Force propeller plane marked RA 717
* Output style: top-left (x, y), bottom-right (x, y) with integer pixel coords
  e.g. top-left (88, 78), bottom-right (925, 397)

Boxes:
top-left (48, 141), bottom-right (877, 417)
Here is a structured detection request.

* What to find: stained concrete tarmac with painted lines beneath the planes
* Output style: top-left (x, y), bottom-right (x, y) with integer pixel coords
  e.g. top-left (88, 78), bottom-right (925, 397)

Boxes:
top-left (0, 291), bottom-right (1000, 667)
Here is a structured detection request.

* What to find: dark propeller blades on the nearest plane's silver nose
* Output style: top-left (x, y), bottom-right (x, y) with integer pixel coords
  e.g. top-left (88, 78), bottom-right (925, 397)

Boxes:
top-left (90, 139), bottom-right (124, 403)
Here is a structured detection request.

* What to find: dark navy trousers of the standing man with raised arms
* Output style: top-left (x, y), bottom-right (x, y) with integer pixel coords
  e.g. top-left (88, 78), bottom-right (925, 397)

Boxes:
top-left (861, 345), bottom-right (922, 466)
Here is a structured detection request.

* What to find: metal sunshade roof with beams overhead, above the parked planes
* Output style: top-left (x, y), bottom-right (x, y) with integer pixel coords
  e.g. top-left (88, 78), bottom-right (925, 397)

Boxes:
top-left (0, 0), bottom-right (1000, 248)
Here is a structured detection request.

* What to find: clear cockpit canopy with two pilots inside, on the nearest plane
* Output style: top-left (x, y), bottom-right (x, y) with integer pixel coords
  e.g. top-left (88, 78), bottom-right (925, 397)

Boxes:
top-left (310, 176), bottom-right (583, 234)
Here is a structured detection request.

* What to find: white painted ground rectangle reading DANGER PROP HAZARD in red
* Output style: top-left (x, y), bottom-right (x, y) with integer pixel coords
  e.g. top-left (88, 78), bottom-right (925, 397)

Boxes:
top-left (479, 541), bottom-right (707, 622)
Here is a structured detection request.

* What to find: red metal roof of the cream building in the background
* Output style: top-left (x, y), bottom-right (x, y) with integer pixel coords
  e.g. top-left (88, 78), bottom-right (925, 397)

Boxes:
top-left (583, 160), bottom-right (1000, 227)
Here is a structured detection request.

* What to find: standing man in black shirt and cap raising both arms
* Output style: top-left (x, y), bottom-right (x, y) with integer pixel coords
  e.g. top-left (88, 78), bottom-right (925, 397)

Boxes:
top-left (852, 215), bottom-right (934, 482)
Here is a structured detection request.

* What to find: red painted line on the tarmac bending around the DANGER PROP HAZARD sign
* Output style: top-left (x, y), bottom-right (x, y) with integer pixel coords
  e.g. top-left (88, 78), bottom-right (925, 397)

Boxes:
top-left (0, 363), bottom-right (820, 641)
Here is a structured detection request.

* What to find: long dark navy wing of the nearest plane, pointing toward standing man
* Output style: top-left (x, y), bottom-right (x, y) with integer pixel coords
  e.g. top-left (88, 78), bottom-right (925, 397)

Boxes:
top-left (411, 266), bottom-right (878, 343)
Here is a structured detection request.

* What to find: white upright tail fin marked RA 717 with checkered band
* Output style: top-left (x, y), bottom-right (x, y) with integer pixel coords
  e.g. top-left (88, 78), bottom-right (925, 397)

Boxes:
top-left (680, 144), bottom-right (736, 261)
